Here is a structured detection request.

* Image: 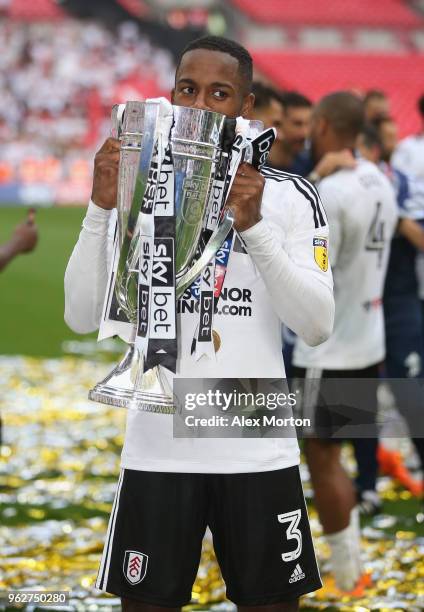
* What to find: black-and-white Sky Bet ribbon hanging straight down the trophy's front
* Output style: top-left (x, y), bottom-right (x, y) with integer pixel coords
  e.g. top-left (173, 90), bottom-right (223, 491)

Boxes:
top-left (135, 100), bottom-right (177, 372)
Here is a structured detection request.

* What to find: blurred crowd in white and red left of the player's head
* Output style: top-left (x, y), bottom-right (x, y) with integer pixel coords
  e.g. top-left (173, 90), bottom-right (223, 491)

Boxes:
top-left (0, 19), bottom-right (173, 192)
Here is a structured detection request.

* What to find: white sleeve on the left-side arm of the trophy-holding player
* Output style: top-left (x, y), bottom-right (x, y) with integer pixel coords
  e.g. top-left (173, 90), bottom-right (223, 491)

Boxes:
top-left (65, 201), bottom-right (113, 334)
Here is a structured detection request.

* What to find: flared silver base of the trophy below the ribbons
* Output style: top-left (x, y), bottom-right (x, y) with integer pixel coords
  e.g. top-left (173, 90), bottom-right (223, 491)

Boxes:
top-left (88, 345), bottom-right (175, 414)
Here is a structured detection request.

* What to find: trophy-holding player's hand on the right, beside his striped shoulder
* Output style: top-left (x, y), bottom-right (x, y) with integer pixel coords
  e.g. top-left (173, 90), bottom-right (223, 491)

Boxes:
top-left (227, 162), bottom-right (265, 232)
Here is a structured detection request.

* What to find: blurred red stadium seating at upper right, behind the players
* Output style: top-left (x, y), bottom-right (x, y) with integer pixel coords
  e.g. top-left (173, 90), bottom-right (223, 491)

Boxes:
top-left (231, 0), bottom-right (424, 136)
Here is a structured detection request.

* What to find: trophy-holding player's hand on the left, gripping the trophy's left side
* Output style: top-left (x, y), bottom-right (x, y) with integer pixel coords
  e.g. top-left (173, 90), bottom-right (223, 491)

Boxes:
top-left (91, 138), bottom-right (120, 210)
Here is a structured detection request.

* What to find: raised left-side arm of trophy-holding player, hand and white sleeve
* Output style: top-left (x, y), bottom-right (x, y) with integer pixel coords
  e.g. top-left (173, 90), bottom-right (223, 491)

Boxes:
top-left (65, 138), bottom-right (119, 334)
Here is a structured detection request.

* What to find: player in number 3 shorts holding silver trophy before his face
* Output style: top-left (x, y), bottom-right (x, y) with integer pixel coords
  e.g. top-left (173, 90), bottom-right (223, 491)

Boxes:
top-left (65, 37), bottom-right (334, 612)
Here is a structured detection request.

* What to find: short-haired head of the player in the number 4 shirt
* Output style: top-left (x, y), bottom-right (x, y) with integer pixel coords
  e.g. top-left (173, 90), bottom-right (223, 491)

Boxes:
top-left (316, 91), bottom-right (365, 139)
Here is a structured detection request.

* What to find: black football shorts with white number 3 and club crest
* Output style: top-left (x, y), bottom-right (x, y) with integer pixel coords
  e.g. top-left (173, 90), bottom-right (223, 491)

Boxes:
top-left (96, 466), bottom-right (322, 607)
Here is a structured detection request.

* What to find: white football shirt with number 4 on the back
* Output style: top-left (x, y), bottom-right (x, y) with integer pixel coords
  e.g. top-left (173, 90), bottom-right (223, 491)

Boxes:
top-left (294, 160), bottom-right (397, 370)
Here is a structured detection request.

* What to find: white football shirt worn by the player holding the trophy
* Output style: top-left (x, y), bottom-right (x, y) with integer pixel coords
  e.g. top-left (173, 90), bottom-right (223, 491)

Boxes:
top-left (65, 169), bottom-right (334, 473)
